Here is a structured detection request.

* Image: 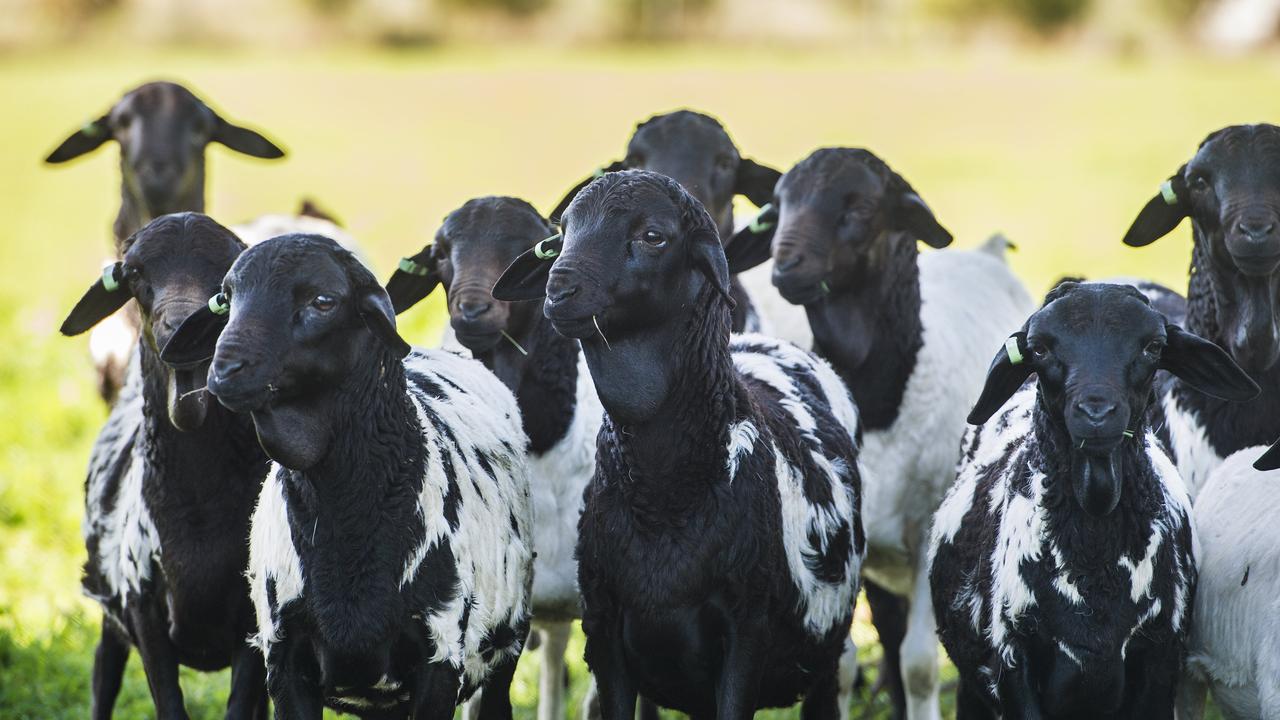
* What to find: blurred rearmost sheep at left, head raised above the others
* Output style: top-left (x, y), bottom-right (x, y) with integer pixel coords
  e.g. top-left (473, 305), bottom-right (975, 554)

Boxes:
top-left (45, 82), bottom-right (284, 402)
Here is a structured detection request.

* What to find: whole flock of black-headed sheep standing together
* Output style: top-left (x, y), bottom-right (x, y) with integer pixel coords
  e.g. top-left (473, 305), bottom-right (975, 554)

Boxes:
top-left (49, 83), bottom-right (1280, 720)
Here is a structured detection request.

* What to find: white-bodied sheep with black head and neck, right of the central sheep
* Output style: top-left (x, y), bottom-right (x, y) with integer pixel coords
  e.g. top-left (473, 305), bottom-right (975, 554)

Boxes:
top-left (726, 147), bottom-right (1032, 719)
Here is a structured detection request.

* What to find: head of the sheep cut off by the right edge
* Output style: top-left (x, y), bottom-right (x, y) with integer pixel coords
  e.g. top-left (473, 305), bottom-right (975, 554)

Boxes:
top-left (1125, 124), bottom-right (1280, 372)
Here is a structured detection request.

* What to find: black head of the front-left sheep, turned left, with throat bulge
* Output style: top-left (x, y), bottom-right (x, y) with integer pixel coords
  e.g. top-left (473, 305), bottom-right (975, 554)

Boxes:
top-left (163, 234), bottom-right (410, 470)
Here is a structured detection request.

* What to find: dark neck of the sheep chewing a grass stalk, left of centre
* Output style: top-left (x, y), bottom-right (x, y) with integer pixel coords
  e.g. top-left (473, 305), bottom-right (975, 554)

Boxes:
top-left (476, 313), bottom-right (579, 455)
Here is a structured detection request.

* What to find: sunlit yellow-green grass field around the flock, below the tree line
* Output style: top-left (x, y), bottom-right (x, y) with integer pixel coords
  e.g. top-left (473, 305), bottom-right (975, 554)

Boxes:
top-left (0, 47), bottom-right (1264, 719)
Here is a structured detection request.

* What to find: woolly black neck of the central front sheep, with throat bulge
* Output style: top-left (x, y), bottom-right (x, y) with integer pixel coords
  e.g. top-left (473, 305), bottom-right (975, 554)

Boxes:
top-left (582, 287), bottom-right (741, 491)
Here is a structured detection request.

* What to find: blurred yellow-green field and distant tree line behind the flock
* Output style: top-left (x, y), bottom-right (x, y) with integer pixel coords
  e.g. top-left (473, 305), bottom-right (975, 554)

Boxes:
top-left (0, 0), bottom-right (1280, 717)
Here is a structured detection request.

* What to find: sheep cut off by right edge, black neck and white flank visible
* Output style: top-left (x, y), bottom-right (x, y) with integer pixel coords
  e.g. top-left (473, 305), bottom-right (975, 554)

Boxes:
top-left (1124, 124), bottom-right (1280, 498)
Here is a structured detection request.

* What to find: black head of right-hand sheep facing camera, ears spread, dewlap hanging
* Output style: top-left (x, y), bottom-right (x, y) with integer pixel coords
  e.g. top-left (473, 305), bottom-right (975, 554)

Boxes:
top-left (969, 282), bottom-right (1258, 516)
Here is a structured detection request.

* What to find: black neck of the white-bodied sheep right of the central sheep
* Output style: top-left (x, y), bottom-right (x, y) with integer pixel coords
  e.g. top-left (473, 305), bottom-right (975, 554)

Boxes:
top-left (805, 232), bottom-right (924, 430)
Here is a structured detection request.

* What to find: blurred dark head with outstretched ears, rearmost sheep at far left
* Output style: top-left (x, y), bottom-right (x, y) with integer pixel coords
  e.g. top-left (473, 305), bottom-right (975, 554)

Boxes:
top-left (46, 82), bottom-right (284, 220)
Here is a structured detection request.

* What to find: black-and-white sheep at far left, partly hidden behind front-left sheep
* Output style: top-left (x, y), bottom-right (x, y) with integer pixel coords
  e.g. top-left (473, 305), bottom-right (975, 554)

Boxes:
top-left (61, 213), bottom-right (268, 717)
